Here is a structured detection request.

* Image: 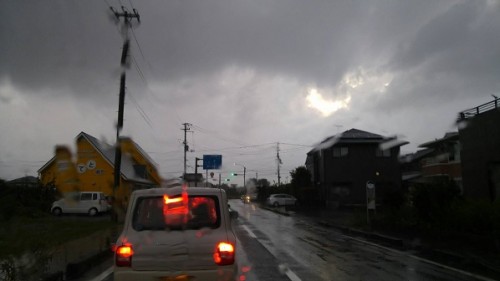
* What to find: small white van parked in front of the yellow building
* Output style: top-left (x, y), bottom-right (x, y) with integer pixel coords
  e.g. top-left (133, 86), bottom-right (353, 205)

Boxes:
top-left (50, 191), bottom-right (111, 216)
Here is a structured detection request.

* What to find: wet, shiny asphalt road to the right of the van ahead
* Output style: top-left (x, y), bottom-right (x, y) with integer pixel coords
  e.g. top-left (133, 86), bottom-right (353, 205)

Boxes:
top-left (94, 197), bottom-right (489, 281)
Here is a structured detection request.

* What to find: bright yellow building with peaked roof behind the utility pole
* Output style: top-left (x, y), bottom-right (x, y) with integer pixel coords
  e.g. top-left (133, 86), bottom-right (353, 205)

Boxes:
top-left (38, 132), bottom-right (161, 204)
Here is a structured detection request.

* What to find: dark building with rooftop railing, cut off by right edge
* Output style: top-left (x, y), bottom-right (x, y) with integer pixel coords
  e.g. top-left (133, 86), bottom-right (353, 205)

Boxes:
top-left (458, 98), bottom-right (500, 201)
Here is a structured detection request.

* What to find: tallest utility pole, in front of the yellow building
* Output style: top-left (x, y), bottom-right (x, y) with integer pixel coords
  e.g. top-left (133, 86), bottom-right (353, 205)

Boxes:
top-left (110, 6), bottom-right (140, 206)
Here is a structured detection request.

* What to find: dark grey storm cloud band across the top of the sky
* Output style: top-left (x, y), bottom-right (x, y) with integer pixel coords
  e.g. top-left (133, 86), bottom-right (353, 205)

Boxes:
top-left (0, 0), bottom-right (500, 106)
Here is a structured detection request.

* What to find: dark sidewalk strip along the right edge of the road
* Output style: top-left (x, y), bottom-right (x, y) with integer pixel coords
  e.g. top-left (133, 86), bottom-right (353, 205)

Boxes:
top-left (264, 203), bottom-right (500, 280)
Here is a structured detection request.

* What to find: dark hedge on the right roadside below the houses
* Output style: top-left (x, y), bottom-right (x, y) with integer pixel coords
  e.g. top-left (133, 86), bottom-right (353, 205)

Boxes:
top-left (365, 181), bottom-right (500, 253)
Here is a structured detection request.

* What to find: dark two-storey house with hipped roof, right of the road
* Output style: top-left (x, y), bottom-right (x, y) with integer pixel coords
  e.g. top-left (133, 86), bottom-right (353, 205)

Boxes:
top-left (306, 129), bottom-right (408, 207)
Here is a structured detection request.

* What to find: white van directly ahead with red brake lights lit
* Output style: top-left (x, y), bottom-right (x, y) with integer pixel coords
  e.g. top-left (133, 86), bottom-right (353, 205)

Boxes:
top-left (113, 185), bottom-right (237, 281)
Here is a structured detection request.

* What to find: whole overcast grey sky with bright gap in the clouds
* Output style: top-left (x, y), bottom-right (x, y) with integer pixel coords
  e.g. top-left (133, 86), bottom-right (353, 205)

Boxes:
top-left (0, 0), bottom-right (500, 183)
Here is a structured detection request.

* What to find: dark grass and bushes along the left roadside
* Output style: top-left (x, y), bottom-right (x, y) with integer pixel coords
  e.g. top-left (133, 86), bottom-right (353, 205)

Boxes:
top-left (0, 180), bottom-right (116, 281)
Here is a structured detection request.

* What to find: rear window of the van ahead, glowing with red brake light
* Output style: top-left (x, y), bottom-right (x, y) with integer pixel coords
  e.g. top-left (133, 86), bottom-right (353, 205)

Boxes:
top-left (132, 195), bottom-right (220, 231)
